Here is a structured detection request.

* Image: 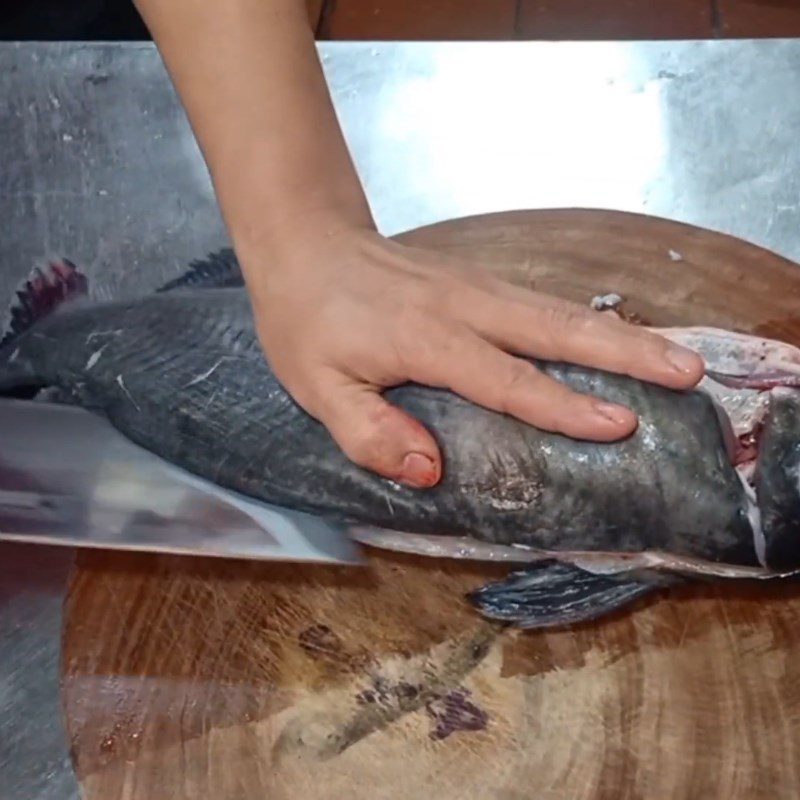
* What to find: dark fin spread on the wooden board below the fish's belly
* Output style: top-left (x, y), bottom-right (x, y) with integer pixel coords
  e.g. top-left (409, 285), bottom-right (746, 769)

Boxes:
top-left (468, 561), bottom-right (679, 628)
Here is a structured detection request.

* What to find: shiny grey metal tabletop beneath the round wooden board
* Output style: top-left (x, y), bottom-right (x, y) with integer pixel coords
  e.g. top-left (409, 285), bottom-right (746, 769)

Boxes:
top-left (0, 41), bottom-right (800, 800)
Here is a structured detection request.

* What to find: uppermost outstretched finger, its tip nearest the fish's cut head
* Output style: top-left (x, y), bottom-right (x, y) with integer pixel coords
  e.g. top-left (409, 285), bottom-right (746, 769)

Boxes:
top-left (461, 286), bottom-right (704, 389)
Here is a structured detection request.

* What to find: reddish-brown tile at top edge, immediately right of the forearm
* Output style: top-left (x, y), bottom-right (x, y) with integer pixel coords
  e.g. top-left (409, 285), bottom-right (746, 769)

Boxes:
top-left (320, 0), bottom-right (516, 41)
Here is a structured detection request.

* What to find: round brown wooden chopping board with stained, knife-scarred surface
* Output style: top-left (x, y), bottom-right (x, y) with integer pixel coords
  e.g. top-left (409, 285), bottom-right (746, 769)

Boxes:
top-left (62, 210), bottom-right (800, 800)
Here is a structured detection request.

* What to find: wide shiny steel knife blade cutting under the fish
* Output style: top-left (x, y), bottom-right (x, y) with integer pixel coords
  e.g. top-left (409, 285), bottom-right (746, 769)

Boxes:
top-left (0, 399), bottom-right (364, 564)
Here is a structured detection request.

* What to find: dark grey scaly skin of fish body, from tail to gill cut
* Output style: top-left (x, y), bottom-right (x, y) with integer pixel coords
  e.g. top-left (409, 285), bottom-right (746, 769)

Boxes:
top-left (0, 268), bottom-right (758, 565)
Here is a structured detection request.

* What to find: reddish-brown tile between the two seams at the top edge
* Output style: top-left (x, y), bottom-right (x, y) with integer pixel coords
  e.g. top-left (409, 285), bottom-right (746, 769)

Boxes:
top-left (517, 0), bottom-right (714, 40)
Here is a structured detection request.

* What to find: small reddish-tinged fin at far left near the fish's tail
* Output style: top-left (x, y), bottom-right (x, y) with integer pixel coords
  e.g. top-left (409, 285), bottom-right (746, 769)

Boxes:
top-left (0, 258), bottom-right (89, 347)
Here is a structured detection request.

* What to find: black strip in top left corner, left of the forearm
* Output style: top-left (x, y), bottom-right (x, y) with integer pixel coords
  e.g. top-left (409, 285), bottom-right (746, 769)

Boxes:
top-left (0, 0), bottom-right (150, 42)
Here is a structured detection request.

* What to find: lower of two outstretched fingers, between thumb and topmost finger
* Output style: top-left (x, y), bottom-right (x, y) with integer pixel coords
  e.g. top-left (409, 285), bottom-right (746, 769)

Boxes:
top-left (410, 330), bottom-right (636, 441)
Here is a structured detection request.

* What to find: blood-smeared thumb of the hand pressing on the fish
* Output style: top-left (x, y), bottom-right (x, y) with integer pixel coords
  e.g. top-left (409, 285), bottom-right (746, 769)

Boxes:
top-left (315, 382), bottom-right (442, 489)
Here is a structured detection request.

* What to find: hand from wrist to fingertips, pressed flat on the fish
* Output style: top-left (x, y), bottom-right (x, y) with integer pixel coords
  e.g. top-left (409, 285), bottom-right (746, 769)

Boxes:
top-left (240, 226), bottom-right (704, 487)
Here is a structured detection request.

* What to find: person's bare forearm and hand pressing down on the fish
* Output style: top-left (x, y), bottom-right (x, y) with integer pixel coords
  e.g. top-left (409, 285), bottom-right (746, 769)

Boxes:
top-left (131, 0), bottom-right (703, 487)
